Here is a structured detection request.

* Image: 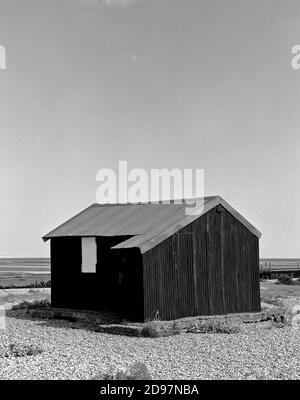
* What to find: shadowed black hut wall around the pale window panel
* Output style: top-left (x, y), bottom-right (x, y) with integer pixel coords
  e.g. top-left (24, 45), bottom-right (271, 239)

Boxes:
top-left (50, 236), bottom-right (143, 320)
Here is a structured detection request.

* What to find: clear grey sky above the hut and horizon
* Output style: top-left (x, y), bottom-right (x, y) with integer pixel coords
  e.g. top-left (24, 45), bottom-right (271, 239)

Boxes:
top-left (0, 0), bottom-right (300, 257)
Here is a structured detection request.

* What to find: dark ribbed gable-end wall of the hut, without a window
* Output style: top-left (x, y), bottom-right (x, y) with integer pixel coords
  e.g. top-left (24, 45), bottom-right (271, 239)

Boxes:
top-left (143, 206), bottom-right (260, 320)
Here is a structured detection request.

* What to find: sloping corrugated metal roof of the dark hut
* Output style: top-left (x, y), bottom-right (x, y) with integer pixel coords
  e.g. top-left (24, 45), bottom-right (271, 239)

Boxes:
top-left (43, 196), bottom-right (261, 252)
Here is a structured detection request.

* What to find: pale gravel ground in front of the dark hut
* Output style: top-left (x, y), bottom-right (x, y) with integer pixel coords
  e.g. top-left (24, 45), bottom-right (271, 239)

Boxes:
top-left (0, 318), bottom-right (300, 379)
